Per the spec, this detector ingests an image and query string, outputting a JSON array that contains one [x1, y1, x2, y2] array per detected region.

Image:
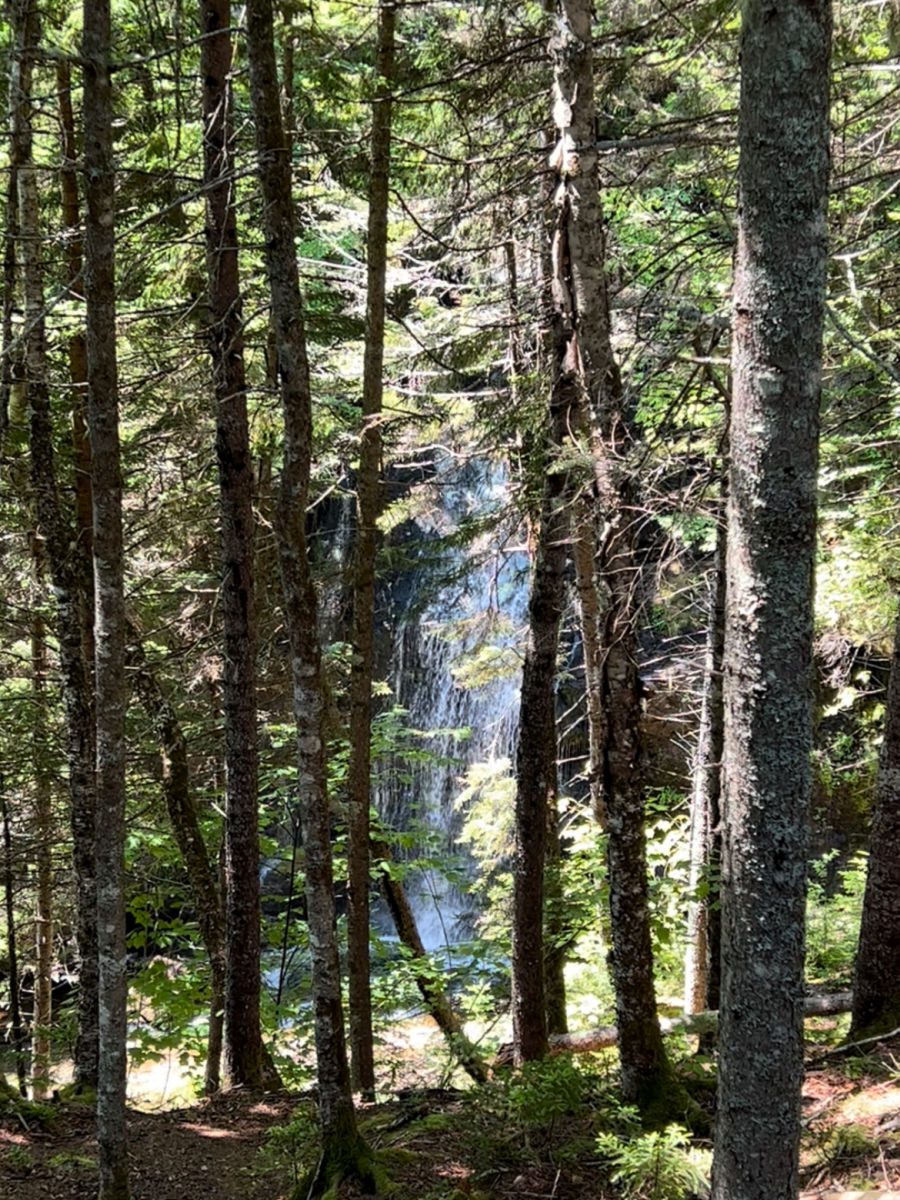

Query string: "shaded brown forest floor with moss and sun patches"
[[0, 1022, 900, 1200]]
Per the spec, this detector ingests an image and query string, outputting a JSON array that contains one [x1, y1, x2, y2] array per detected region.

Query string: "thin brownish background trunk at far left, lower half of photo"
[[31, 566, 53, 1100]]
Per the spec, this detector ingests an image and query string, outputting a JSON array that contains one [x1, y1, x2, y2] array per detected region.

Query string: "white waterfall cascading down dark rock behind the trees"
[[376, 456, 528, 949]]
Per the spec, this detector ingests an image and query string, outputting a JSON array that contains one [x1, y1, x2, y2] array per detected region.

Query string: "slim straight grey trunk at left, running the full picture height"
[[79, 0, 128, 1200]]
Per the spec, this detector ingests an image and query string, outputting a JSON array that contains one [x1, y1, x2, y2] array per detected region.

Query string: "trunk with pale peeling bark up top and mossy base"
[[551, 0, 671, 1117]]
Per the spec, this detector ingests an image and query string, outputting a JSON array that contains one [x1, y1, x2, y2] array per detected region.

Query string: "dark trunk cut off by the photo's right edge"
[[850, 609, 900, 1038]]
